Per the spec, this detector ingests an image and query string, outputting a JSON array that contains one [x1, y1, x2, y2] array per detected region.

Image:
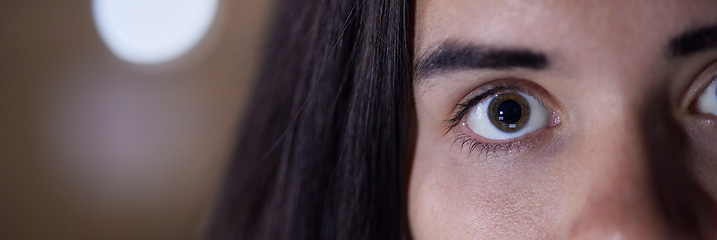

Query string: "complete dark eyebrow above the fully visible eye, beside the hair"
[[414, 42, 548, 80]]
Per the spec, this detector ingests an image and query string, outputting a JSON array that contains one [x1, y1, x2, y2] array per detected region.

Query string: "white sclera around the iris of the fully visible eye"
[[466, 93, 548, 140]]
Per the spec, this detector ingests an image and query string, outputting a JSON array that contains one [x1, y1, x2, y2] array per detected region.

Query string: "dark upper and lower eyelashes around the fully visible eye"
[[445, 83, 542, 157]]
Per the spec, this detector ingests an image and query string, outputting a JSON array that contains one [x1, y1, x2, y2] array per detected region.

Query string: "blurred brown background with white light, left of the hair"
[[0, 0, 273, 239]]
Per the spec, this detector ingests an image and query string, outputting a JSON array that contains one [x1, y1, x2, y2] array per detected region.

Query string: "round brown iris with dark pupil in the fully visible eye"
[[488, 93, 530, 132]]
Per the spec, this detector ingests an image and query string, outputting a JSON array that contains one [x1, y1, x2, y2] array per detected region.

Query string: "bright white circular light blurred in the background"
[[92, 0, 218, 64]]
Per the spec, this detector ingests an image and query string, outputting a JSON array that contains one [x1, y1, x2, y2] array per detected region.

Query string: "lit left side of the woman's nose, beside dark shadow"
[[570, 99, 666, 239]]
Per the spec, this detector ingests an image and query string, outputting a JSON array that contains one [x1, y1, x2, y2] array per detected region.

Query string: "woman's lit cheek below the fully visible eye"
[[408, 130, 567, 240]]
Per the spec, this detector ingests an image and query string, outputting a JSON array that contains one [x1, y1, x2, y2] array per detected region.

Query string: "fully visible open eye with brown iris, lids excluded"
[[464, 92, 549, 140]]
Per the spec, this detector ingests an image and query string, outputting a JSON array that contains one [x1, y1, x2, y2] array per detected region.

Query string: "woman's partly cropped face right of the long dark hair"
[[409, 0, 717, 239]]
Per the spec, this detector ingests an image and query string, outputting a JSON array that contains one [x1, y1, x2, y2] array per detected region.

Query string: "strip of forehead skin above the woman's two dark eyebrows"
[[416, 0, 717, 56]]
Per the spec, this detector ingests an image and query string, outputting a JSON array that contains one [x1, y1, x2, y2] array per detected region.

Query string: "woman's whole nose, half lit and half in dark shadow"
[[571, 90, 714, 239]]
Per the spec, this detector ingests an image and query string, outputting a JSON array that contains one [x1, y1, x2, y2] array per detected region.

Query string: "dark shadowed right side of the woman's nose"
[[640, 96, 715, 239]]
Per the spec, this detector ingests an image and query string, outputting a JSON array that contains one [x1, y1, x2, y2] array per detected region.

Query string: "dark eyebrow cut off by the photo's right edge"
[[669, 25, 717, 58]]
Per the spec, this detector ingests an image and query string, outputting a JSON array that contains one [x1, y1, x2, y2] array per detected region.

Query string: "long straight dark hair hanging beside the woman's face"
[[208, 0, 414, 239]]
